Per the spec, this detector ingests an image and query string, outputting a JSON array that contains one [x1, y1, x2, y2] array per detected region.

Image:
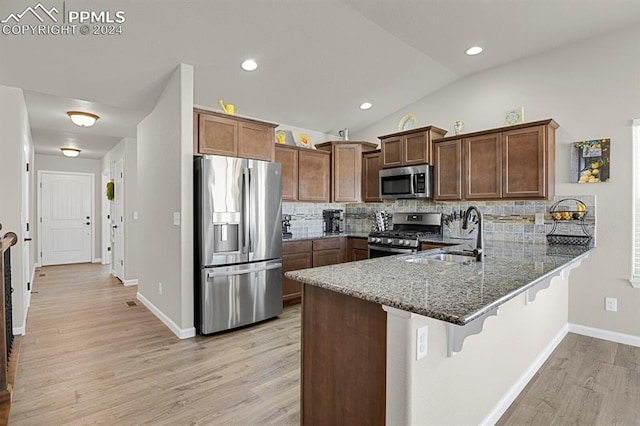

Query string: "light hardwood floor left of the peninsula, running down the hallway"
[[9, 264, 300, 425]]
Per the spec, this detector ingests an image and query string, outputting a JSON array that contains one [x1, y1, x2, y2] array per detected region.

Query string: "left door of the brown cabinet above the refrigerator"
[[198, 114, 238, 157]]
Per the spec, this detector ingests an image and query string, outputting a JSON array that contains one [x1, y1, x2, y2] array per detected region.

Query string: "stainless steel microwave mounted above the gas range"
[[379, 164, 433, 199]]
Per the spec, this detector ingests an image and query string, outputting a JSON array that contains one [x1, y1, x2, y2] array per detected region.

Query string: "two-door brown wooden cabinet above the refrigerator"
[[194, 109, 276, 161]]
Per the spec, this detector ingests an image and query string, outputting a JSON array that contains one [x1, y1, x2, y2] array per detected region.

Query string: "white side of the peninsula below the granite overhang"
[[387, 275, 568, 426]]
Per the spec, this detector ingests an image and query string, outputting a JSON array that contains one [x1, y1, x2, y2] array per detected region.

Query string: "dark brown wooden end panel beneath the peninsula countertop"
[[300, 284, 387, 426]]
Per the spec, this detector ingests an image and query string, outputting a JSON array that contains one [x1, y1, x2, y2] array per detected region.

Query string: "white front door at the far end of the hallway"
[[40, 172, 93, 265]]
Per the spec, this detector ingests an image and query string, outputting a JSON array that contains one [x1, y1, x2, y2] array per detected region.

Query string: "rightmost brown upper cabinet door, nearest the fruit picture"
[[502, 126, 547, 198]]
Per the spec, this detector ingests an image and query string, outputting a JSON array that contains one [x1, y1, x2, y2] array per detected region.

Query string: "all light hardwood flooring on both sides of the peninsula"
[[9, 264, 640, 426]]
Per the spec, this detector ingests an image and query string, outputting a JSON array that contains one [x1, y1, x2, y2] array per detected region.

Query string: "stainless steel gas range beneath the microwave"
[[368, 212, 442, 259]]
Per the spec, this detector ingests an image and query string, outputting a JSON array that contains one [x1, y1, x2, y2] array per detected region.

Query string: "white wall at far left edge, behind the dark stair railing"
[[0, 86, 35, 334]]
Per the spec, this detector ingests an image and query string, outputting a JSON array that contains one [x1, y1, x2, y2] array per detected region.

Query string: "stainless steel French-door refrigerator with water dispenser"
[[194, 155, 282, 334]]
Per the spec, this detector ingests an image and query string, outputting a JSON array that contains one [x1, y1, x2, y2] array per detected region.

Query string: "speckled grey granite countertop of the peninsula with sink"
[[285, 242, 591, 325]]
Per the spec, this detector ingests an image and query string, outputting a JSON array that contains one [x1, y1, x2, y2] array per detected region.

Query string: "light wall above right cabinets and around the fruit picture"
[[352, 27, 640, 336]]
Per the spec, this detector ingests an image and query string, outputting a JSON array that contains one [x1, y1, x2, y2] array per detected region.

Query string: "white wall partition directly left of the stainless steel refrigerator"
[[137, 64, 195, 337]]
